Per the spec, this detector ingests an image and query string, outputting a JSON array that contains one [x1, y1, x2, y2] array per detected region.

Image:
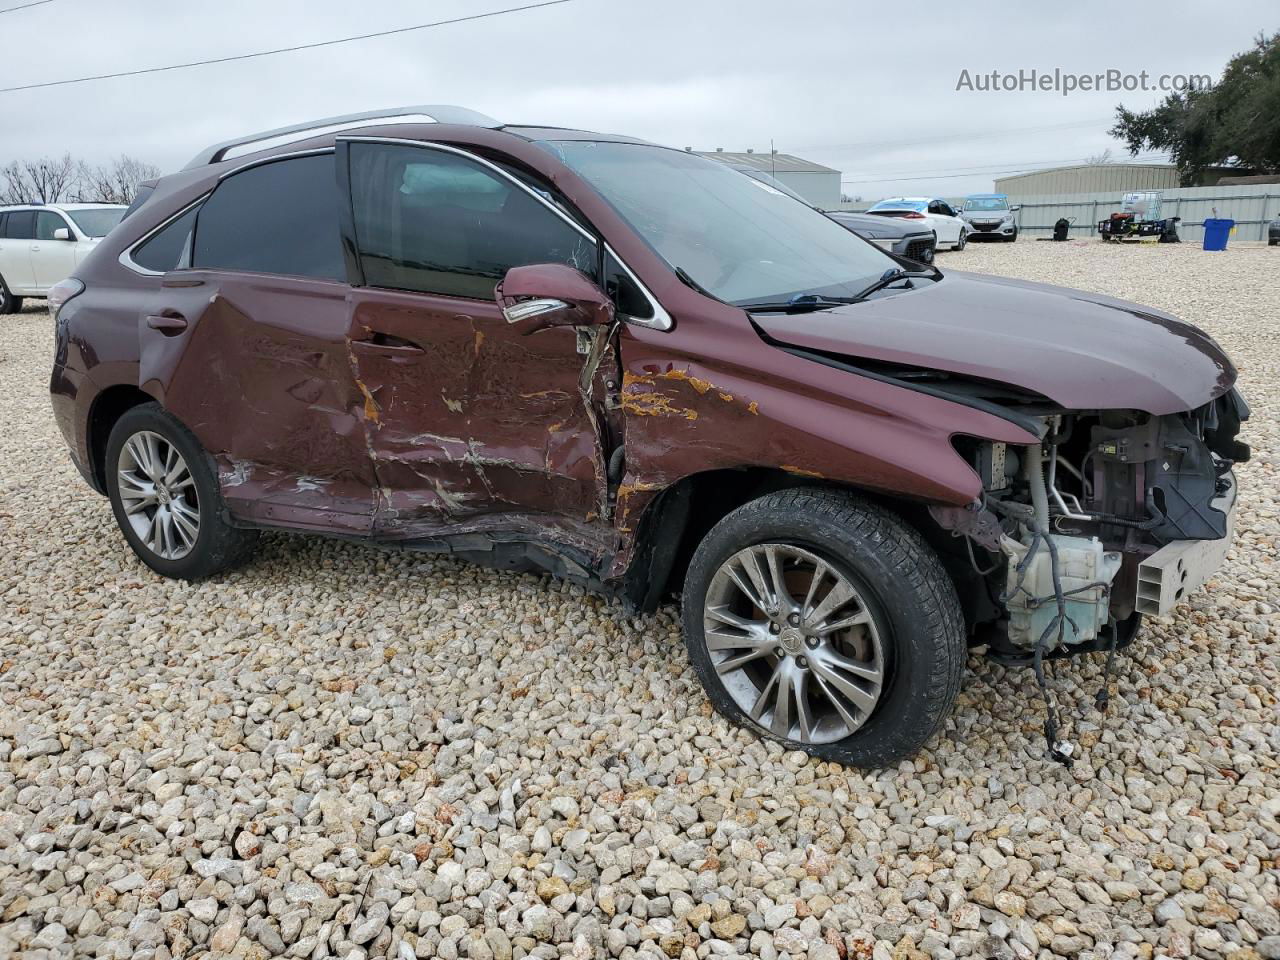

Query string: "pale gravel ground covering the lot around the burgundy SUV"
[[0, 239, 1280, 960]]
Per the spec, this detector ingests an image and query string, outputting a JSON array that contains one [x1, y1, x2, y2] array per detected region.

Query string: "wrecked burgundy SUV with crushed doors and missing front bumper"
[[51, 106, 1248, 765]]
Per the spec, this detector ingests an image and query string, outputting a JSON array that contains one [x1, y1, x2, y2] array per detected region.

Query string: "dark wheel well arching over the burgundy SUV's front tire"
[[623, 467, 964, 611]]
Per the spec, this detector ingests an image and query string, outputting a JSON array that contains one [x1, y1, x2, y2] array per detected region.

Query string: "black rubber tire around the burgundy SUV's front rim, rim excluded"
[[682, 489, 968, 768]]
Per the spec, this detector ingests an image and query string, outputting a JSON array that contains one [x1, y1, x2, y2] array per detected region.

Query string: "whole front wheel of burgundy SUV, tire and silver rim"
[[684, 489, 966, 767]]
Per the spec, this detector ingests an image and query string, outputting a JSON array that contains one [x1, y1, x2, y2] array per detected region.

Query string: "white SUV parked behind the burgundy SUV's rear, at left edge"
[[0, 204, 127, 314]]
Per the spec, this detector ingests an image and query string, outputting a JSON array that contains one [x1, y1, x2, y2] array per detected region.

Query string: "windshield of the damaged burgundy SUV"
[[543, 141, 897, 305]]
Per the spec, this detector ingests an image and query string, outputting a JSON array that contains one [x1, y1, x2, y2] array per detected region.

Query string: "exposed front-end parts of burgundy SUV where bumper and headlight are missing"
[[933, 389, 1249, 662]]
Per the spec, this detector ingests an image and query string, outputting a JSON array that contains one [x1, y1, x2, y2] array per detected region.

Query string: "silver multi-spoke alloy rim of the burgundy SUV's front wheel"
[[703, 543, 884, 744]]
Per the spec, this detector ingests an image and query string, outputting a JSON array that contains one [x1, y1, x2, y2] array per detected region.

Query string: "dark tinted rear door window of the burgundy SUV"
[[191, 154, 347, 280]]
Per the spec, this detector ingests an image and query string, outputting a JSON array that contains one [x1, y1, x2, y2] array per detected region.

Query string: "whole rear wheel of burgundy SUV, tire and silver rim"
[[106, 403, 257, 580]]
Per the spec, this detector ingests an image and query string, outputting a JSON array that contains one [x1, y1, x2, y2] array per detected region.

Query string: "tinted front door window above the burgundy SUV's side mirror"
[[351, 143, 599, 300]]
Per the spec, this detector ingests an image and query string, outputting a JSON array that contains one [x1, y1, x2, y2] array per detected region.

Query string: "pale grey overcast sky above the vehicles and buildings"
[[0, 0, 1280, 200]]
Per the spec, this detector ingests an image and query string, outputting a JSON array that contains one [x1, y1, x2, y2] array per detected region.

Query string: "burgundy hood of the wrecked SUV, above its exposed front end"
[[754, 271, 1235, 416]]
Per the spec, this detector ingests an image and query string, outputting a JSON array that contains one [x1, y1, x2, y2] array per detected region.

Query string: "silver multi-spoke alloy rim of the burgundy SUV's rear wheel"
[[116, 430, 200, 561]]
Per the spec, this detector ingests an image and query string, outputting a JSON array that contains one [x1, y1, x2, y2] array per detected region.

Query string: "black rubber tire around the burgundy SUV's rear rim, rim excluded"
[[104, 403, 259, 580]]
